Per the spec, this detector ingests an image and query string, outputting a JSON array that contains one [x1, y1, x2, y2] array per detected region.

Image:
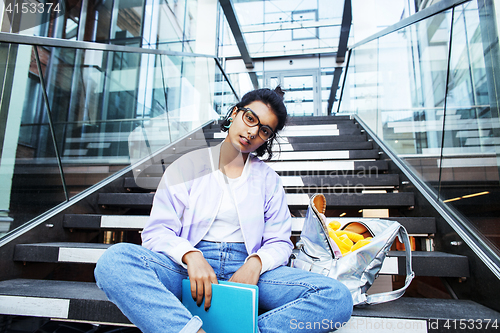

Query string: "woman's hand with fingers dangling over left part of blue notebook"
[[182, 251, 219, 311]]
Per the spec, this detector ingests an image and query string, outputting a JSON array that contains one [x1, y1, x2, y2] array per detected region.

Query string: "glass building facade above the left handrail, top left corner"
[[0, 0, 218, 56]]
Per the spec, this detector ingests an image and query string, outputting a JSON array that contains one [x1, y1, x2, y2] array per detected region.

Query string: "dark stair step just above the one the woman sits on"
[[10, 243, 469, 277]]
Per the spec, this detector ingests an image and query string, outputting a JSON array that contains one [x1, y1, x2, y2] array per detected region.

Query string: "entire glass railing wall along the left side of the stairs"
[[0, 37, 237, 235]]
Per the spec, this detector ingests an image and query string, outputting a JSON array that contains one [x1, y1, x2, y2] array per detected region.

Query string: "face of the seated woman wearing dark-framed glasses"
[[225, 101, 278, 153]]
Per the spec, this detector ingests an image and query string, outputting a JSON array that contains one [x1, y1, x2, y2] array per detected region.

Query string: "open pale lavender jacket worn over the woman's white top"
[[142, 145, 293, 269]]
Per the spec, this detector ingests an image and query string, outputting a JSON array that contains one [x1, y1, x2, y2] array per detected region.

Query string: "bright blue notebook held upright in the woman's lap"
[[182, 279, 259, 333]]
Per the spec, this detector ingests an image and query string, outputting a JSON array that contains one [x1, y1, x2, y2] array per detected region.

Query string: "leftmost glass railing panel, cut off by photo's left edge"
[[0, 43, 66, 236]]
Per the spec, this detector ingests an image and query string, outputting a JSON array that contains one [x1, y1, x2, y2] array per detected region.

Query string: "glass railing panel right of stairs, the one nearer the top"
[[341, 11, 451, 195]]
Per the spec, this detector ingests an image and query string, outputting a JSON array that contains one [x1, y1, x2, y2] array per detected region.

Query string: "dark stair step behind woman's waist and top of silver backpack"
[[63, 214, 436, 235]]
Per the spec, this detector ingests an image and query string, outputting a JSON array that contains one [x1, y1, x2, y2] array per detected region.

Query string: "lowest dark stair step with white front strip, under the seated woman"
[[0, 279, 500, 332]]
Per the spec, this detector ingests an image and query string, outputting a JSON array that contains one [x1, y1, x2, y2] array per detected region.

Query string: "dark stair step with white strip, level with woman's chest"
[[123, 174, 399, 190]]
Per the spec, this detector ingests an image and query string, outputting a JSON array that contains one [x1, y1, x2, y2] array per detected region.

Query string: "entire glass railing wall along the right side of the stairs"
[[341, 1, 500, 253]]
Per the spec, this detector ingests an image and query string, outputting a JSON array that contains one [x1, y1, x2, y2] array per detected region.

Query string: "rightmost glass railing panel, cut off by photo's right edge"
[[439, 1, 500, 252]]
